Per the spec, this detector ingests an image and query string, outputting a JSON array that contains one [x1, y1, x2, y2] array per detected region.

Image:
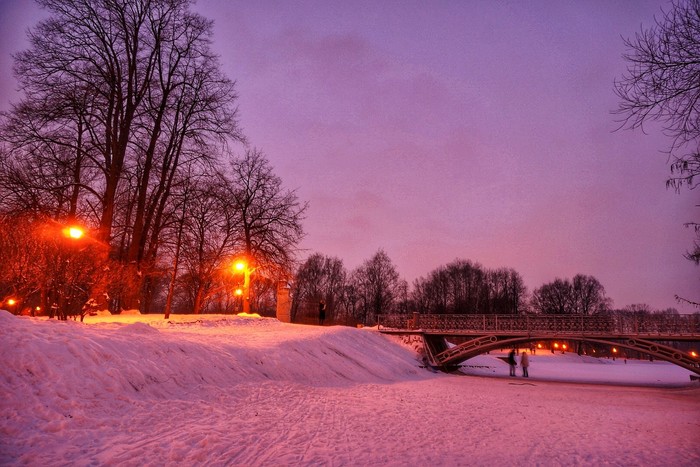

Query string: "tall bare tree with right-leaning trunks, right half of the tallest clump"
[[128, 12, 242, 270]]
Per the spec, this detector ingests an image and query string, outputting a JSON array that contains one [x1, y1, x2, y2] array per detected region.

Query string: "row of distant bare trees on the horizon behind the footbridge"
[[291, 250, 696, 325]]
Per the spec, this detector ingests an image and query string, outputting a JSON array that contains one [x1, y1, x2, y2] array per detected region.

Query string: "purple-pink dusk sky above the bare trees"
[[0, 0, 700, 311]]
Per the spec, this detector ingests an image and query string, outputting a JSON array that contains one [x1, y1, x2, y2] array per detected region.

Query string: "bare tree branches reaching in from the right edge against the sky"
[[615, 0, 700, 272]]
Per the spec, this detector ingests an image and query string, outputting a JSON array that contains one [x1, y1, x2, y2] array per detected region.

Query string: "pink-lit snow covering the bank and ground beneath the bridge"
[[0, 311, 700, 466]]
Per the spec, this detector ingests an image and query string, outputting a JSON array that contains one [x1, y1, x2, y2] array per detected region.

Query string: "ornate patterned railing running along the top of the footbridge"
[[378, 313, 700, 336]]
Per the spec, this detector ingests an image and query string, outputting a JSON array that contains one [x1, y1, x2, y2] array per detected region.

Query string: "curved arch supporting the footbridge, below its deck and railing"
[[423, 334, 700, 375]]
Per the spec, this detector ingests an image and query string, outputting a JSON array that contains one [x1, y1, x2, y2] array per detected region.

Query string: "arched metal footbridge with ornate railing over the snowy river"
[[378, 313, 700, 375]]
